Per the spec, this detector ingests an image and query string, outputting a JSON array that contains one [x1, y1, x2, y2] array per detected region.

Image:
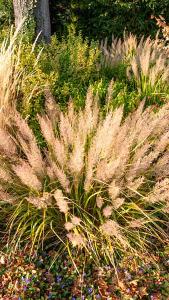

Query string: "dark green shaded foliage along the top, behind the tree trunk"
[[0, 0, 169, 40]]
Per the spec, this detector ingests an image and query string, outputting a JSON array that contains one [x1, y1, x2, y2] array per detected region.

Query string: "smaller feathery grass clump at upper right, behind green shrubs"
[[101, 34, 169, 102]]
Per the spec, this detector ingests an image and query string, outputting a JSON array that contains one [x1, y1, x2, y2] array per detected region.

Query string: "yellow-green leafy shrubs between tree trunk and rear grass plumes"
[[16, 34, 100, 114]]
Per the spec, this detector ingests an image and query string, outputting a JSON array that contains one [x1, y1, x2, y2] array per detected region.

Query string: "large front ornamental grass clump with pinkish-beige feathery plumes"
[[0, 90, 169, 262]]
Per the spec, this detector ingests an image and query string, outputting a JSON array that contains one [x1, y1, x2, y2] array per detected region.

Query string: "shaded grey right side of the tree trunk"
[[35, 0, 51, 43]]
